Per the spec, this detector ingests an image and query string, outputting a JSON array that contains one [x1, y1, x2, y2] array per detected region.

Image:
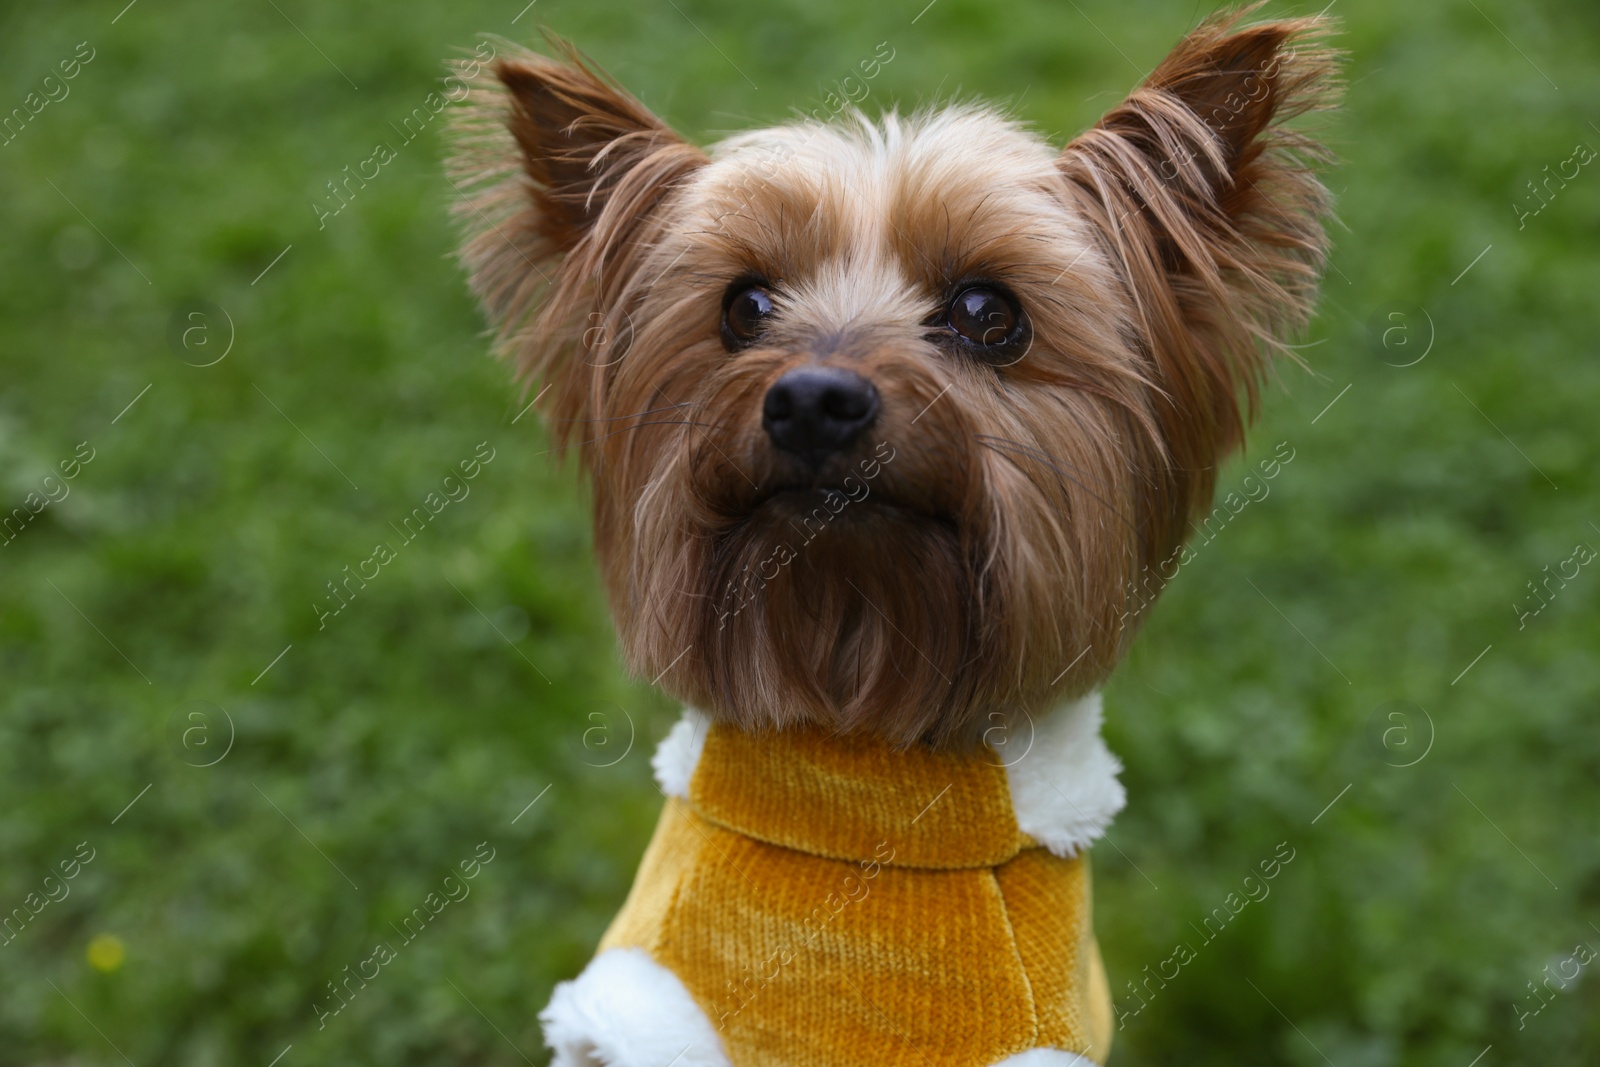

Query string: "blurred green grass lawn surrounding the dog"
[[0, 0, 1600, 1067]]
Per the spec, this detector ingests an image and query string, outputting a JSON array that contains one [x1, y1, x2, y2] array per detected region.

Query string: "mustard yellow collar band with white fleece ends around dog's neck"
[[651, 694, 1125, 869]]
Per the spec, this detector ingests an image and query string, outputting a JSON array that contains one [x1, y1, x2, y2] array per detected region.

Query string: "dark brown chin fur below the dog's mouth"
[[701, 486, 978, 744]]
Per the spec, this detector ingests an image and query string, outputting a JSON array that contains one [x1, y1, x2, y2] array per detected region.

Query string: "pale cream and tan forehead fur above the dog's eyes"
[[664, 106, 1104, 326]]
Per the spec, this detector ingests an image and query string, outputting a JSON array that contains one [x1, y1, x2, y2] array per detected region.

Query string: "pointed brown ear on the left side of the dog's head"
[[450, 37, 706, 442]]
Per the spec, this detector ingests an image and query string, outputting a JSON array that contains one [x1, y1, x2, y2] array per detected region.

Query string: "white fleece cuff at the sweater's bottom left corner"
[[539, 949, 732, 1067]]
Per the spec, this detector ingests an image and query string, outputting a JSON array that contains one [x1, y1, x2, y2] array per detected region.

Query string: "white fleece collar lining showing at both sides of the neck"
[[650, 691, 1128, 857]]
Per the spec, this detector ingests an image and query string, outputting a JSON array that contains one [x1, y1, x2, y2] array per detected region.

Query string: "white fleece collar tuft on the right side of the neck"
[[1006, 691, 1128, 857]]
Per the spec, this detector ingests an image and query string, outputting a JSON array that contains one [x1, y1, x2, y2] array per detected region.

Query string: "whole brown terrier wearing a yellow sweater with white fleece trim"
[[451, 5, 1338, 1067]]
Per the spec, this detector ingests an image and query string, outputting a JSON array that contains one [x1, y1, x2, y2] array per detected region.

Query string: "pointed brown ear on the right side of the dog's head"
[[1059, 3, 1338, 547]]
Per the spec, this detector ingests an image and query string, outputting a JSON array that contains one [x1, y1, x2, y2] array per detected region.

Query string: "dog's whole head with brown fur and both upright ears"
[[458, 8, 1331, 742]]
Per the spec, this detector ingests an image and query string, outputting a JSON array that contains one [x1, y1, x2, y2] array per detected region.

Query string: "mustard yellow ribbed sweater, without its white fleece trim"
[[600, 713, 1112, 1067]]
